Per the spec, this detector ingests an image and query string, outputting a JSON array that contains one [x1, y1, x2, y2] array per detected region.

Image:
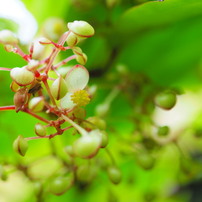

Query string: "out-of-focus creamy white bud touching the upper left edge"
[[0, 29, 18, 45]]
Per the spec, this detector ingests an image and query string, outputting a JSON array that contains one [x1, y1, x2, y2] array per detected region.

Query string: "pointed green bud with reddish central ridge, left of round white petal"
[[50, 76, 67, 100]]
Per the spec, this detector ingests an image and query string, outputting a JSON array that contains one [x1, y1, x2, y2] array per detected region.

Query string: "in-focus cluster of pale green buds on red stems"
[[0, 21, 121, 191]]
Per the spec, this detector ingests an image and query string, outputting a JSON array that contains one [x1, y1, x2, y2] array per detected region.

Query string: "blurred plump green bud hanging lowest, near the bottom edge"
[[49, 176, 73, 196]]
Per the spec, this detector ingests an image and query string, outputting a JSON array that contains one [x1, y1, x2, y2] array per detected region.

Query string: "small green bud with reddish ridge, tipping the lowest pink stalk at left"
[[13, 135, 28, 156]]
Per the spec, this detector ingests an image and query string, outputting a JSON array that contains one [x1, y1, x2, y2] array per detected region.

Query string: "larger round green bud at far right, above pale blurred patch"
[[154, 92, 177, 110]]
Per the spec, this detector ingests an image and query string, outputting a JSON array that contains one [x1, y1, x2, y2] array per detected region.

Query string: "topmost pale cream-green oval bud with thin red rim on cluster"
[[67, 20, 95, 38]]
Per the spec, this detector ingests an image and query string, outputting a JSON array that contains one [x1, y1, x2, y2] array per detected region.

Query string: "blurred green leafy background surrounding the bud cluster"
[[0, 0, 202, 202]]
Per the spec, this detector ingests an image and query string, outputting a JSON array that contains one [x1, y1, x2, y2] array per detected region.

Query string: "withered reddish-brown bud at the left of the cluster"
[[13, 88, 28, 112]]
